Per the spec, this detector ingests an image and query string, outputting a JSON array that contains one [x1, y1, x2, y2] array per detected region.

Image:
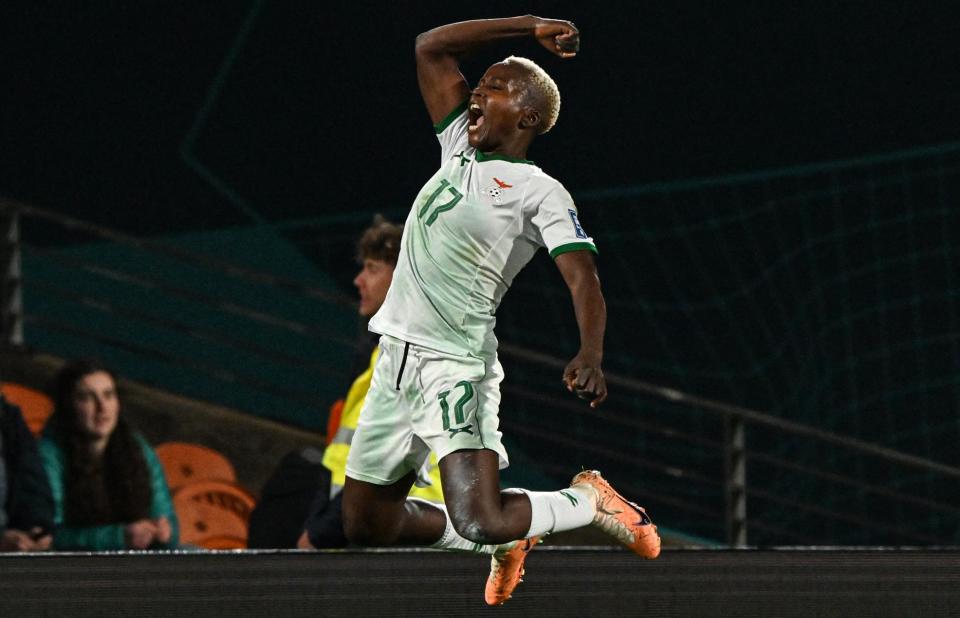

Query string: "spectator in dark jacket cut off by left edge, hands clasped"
[[0, 395, 53, 552]]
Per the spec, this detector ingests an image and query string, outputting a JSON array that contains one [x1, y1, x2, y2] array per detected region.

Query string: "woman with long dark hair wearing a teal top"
[[40, 361, 178, 551]]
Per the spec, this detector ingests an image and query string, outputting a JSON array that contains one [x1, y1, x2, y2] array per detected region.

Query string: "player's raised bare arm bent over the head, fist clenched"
[[416, 15, 580, 124]]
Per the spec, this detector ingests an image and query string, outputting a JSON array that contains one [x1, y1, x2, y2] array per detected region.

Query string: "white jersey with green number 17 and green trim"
[[370, 103, 596, 357]]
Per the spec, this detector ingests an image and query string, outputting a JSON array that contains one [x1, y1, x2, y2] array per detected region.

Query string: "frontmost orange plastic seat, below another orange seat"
[[173, 481, 256, 549]]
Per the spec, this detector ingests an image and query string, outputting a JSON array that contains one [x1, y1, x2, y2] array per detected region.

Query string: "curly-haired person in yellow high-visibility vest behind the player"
[[297, 215, 443, 549]]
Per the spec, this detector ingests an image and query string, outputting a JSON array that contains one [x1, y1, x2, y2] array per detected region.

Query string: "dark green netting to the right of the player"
[[497, 144, 960, 545]]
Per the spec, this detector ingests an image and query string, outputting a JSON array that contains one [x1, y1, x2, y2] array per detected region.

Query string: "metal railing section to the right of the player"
[[500, 344, 960, 547]]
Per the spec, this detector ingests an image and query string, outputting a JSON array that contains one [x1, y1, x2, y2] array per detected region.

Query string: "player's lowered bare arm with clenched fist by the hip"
[[556, 251, 607, 408]]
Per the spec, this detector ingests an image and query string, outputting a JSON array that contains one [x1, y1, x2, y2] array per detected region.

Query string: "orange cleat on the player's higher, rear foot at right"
[[570, 470, 660, 559]]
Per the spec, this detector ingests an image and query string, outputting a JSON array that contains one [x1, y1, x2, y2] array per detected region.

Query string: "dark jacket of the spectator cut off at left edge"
[[0, 396, 53, 532]]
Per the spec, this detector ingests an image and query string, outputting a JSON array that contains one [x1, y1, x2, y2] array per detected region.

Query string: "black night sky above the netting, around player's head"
[[0, 0, 960, 235]]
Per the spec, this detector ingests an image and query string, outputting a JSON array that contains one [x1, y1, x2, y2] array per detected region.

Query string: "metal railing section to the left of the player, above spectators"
[[0, 199, 357, 428]]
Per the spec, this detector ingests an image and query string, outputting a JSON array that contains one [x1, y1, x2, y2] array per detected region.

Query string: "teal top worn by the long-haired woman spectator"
[[39, 434, 180, 551]]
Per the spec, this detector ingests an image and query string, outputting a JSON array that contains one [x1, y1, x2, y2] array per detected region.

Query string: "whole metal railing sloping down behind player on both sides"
[[0, 194, 960, 547]]
